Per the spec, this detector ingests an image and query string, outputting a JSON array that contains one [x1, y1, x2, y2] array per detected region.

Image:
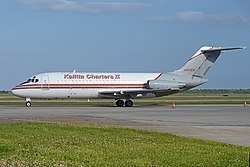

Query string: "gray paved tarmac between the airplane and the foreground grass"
[[0, 105, 250, 146]]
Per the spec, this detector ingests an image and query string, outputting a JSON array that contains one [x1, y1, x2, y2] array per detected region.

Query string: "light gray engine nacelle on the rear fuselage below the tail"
[[147, 80, 186, 89]]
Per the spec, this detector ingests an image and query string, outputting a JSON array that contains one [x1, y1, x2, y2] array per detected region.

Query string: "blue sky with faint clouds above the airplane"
[[0, 0, 250, 90]]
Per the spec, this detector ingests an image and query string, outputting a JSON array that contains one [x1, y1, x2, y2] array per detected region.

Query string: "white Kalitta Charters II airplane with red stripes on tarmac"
[[12, 46, 244, 107]]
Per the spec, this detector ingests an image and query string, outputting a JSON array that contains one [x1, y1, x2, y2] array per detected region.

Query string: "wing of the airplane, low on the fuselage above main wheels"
[[99, 88, 181, 99]]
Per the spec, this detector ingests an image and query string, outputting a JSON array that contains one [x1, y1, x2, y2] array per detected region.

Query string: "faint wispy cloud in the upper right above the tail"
[[150, 11, 250, 24]]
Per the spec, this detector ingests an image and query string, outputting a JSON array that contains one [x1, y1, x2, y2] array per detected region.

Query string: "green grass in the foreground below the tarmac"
[[0, 123, 249, 167]]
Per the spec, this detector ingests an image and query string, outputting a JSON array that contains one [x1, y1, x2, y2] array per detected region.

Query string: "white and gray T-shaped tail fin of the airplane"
[[175, 46, 244, 78]]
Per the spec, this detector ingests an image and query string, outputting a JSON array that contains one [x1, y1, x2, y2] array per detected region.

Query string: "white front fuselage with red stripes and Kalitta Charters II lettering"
[[12, 72, 162, 99]]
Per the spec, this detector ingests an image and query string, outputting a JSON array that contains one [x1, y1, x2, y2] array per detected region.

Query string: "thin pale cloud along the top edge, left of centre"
[[19, 0, 150, 13]]
